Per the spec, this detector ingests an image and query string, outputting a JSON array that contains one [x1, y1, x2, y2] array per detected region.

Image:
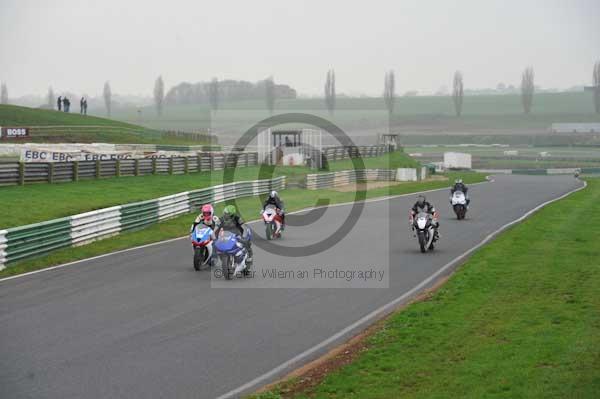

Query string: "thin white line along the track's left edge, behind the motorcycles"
[[0, 181, 488, 283]]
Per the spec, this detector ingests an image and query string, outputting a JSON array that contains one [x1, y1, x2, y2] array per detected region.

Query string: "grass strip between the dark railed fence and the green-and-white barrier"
[[0, 152, 418, 229]]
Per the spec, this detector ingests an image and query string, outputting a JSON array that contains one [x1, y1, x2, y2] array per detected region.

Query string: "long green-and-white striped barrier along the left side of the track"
[[0, 176, 285, 270]]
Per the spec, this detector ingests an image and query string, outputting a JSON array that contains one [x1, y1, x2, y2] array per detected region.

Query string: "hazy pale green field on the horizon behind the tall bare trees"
[[99, 92, 600, 134]]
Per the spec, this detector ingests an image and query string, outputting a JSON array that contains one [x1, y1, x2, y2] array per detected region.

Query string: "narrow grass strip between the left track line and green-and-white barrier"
[[0, 173, 485, 277]]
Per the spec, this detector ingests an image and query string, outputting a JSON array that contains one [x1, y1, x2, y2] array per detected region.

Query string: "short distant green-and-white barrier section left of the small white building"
[[305, 168, 427, 190]]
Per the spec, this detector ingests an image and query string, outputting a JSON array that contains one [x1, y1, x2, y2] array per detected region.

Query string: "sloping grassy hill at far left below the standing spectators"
[[0, 105, 214, 145]]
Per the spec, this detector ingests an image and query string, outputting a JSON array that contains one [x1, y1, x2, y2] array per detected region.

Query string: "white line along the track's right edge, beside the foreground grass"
[[217, 180, 587, 399]]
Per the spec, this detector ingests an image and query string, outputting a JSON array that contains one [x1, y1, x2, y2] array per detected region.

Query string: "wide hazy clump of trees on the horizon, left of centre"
[[164, 78, 297, 105]]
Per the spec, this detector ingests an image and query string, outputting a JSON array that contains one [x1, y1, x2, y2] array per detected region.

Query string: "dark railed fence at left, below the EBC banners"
[[0, 152, 258, 185]]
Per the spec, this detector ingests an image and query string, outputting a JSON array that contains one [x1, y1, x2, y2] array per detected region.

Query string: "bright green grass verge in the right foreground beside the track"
[[258, 179, 600, 398]]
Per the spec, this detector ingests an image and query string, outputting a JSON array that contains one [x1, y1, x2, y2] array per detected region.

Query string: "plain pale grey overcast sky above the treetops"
[[0, 0, 600, 97]]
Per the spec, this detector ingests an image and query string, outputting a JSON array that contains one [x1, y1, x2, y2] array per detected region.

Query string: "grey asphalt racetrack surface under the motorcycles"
[[0, 175, 582, 399]]
